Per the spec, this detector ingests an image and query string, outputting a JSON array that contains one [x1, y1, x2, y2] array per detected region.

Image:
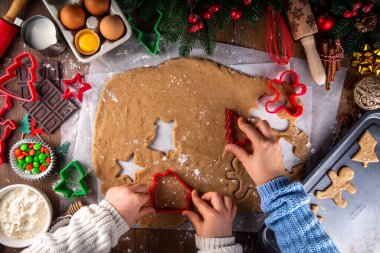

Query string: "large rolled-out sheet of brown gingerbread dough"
[[93, 58, 309, 228]]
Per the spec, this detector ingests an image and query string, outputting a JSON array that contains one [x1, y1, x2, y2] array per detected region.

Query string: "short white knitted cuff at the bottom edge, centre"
[[195, 235, 243, 253]]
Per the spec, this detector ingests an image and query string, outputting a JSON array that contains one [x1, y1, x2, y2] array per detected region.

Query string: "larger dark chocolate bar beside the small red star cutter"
[[19, 79, 78, 134]]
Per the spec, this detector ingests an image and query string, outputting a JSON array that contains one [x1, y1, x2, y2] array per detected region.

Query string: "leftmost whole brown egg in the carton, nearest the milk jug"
[[60, 4, 86, 30]]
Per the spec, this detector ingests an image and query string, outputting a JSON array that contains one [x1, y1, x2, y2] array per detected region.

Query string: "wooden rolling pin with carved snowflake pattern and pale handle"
[[286, 0, 326, 85]]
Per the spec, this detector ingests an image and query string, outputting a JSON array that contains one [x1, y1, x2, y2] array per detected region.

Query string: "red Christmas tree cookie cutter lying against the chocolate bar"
[[0, 52, 38, 102]]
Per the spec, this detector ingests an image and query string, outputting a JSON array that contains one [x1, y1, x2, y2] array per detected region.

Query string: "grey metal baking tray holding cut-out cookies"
[[261, 109, 380, 253]]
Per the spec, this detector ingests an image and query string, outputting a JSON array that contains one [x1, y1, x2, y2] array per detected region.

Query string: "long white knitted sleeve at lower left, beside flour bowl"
[[23, 200, 129, 253]]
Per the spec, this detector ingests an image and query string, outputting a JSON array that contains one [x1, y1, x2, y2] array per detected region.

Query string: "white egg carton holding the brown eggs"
[[42, 0, 132, 62]]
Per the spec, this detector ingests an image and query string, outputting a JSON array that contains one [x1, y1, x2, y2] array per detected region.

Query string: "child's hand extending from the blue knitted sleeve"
[[226, 118, 285, 186]]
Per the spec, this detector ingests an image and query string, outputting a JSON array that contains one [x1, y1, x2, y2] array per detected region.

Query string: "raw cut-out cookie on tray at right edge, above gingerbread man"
[[352, 130, 379, 168]]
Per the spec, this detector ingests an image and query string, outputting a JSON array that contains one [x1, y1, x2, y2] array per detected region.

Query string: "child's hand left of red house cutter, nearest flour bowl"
[[105, 184, 155, 226]]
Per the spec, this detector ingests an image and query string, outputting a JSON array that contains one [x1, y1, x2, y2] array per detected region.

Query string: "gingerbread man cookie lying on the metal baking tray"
[[315, 167, 356, 208]]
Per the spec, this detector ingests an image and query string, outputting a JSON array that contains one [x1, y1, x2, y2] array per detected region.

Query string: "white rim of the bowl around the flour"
[[0, 184, 53, 248]]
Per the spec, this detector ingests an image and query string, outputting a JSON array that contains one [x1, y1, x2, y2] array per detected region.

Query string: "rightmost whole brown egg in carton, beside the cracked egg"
[[100, 15, 125, 40]]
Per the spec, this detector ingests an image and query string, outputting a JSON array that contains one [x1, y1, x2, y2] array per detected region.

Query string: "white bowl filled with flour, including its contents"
[[0, 184, 53, 248]]
